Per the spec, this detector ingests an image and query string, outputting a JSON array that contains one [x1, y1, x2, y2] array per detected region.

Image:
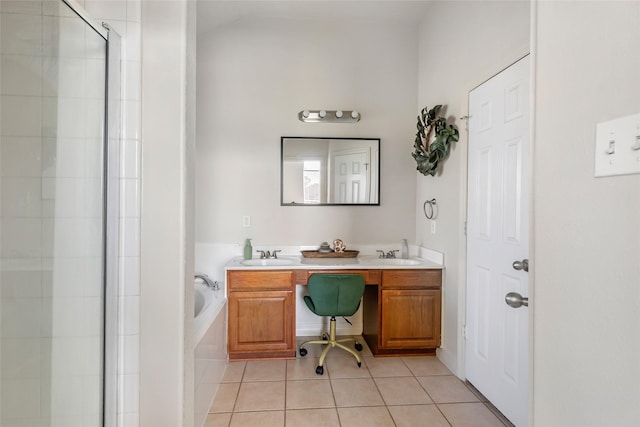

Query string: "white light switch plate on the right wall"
[[595, 114, 640, 177]]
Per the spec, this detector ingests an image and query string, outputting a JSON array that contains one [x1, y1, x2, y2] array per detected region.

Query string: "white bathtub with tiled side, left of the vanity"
[[193, 283, 228, 427]]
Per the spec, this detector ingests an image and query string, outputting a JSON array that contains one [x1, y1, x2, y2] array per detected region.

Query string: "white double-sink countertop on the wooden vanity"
[[225, 255, 444, 270]]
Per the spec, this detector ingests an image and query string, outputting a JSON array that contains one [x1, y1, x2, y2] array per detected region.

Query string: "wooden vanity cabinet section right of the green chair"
[[365, 270, 442, 355]]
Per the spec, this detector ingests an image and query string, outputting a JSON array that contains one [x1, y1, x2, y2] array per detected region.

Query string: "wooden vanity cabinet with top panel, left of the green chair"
[[227, 270, 296, 360]]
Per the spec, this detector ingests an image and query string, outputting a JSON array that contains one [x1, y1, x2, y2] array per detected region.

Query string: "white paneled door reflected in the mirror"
[[331, 151, 371, 203]]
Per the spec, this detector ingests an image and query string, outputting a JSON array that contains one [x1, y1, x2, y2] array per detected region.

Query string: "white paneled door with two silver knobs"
[[465, 56, 530, 427]]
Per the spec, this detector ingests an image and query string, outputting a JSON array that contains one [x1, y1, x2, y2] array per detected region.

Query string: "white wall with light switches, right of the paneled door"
[[533, 1, 640, 426]]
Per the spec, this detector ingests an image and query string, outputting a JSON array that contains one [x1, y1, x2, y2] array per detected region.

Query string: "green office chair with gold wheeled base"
[[300, 274, 364, 375]]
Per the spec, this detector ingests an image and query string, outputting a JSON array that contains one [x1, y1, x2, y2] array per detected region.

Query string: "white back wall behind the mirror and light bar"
[[196, 18, 418, 248]]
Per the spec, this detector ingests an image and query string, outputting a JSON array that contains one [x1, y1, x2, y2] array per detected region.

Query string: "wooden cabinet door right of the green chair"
[[380, 289, 440, 349]]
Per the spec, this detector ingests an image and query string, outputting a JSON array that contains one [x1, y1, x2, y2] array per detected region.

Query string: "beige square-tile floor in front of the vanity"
[[204, 337, 511, 427]]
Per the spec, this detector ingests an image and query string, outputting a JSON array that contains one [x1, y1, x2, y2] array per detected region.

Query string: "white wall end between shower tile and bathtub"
[[140, 0, 194, 426]]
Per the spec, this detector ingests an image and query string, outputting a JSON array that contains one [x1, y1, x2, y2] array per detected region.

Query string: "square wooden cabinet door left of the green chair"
[[229, 291, 295, 353]]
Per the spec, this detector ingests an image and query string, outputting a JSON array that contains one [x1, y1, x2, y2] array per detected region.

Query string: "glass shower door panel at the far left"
[[0, 1, 107, 427]]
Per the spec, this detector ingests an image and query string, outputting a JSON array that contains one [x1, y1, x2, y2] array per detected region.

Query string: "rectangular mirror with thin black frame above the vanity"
[[280, 136, 380, 206]]
